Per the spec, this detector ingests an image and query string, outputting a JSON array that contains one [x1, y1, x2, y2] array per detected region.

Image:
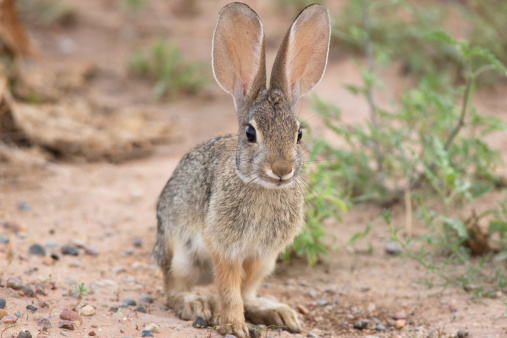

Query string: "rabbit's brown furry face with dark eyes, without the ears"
[[236, 90, 303, 188]]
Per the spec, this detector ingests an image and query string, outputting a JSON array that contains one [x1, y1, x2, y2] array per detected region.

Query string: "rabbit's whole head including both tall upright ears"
[[212, 3, 330, 188]]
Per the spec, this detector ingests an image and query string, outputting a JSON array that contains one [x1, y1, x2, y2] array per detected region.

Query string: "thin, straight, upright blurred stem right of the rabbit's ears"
[[361, 0, 384, 180]]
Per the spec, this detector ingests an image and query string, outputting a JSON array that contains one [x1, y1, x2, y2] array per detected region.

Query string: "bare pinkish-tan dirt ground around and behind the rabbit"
[[0, 0, 507, 337]]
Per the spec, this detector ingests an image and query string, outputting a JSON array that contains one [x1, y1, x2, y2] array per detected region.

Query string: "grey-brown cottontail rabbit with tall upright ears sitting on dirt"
[[152, 3, 331, 337]]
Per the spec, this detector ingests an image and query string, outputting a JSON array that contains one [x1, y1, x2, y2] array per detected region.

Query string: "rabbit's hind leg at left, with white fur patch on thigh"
[[163, 241, 215, 323]]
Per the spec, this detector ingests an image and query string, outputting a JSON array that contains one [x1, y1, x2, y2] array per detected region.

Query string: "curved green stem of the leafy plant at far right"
[[382, 75, 473, 208]]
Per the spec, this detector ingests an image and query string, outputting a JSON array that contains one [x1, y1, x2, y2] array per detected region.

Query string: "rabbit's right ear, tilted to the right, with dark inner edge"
[[271, 4, 331, 107]]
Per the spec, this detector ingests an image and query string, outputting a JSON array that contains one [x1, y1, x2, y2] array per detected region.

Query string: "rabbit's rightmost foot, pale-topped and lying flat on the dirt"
[[245, 298, 302, 332]]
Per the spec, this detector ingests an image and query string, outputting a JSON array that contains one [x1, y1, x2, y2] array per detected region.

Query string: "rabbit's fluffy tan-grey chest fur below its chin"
[[205, 186, 304, 257]]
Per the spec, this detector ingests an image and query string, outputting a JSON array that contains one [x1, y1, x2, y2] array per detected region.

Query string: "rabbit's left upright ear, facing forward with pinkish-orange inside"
[[212, 2, 266, 110]]
